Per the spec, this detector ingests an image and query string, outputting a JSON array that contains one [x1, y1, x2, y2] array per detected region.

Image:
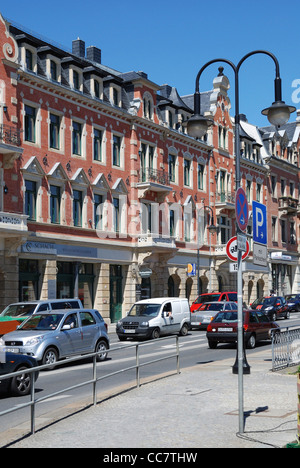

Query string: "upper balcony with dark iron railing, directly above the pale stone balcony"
[[137, 168, 172, 199]]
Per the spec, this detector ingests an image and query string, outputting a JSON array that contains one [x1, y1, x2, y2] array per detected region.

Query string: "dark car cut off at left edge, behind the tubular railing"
[[0, 353, 39, 396]]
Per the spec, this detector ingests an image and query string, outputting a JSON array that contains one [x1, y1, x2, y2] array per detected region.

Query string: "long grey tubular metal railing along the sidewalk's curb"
[[0, 335, 180, 434]]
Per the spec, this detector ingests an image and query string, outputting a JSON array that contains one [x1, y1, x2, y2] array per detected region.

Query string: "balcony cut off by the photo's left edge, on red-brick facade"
[[0, 124, 23, 169]]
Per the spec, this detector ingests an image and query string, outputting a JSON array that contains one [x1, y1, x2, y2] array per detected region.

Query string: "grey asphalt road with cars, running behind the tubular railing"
[[0, 313, 300, 440]]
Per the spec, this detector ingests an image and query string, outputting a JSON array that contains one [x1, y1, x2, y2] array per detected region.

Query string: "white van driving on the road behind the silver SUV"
[[116, 297, 191, 341]]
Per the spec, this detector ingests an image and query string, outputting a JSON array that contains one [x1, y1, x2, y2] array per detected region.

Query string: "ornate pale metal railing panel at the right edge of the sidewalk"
[[272, 327, 300, 371]]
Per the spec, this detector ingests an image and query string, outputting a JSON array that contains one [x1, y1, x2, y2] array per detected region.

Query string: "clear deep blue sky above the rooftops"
[[0, 0, 300, 127]]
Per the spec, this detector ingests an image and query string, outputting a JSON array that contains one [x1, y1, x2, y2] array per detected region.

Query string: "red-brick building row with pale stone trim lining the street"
[[0, 16, 300, 322]]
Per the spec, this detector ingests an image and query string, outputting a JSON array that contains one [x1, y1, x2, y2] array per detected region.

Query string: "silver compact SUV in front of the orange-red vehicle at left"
[[0, 309, 109, 365]]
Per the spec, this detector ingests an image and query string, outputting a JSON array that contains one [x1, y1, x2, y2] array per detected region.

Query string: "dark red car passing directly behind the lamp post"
[[206, 310, 279, 349]]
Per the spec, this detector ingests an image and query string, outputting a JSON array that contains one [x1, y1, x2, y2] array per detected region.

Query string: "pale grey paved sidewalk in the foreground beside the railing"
[[5, 351, 298, 450]]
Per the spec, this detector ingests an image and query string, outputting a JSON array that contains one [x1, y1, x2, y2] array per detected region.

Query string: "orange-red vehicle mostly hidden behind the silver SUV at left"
[[0, 299, 83, 336]]
